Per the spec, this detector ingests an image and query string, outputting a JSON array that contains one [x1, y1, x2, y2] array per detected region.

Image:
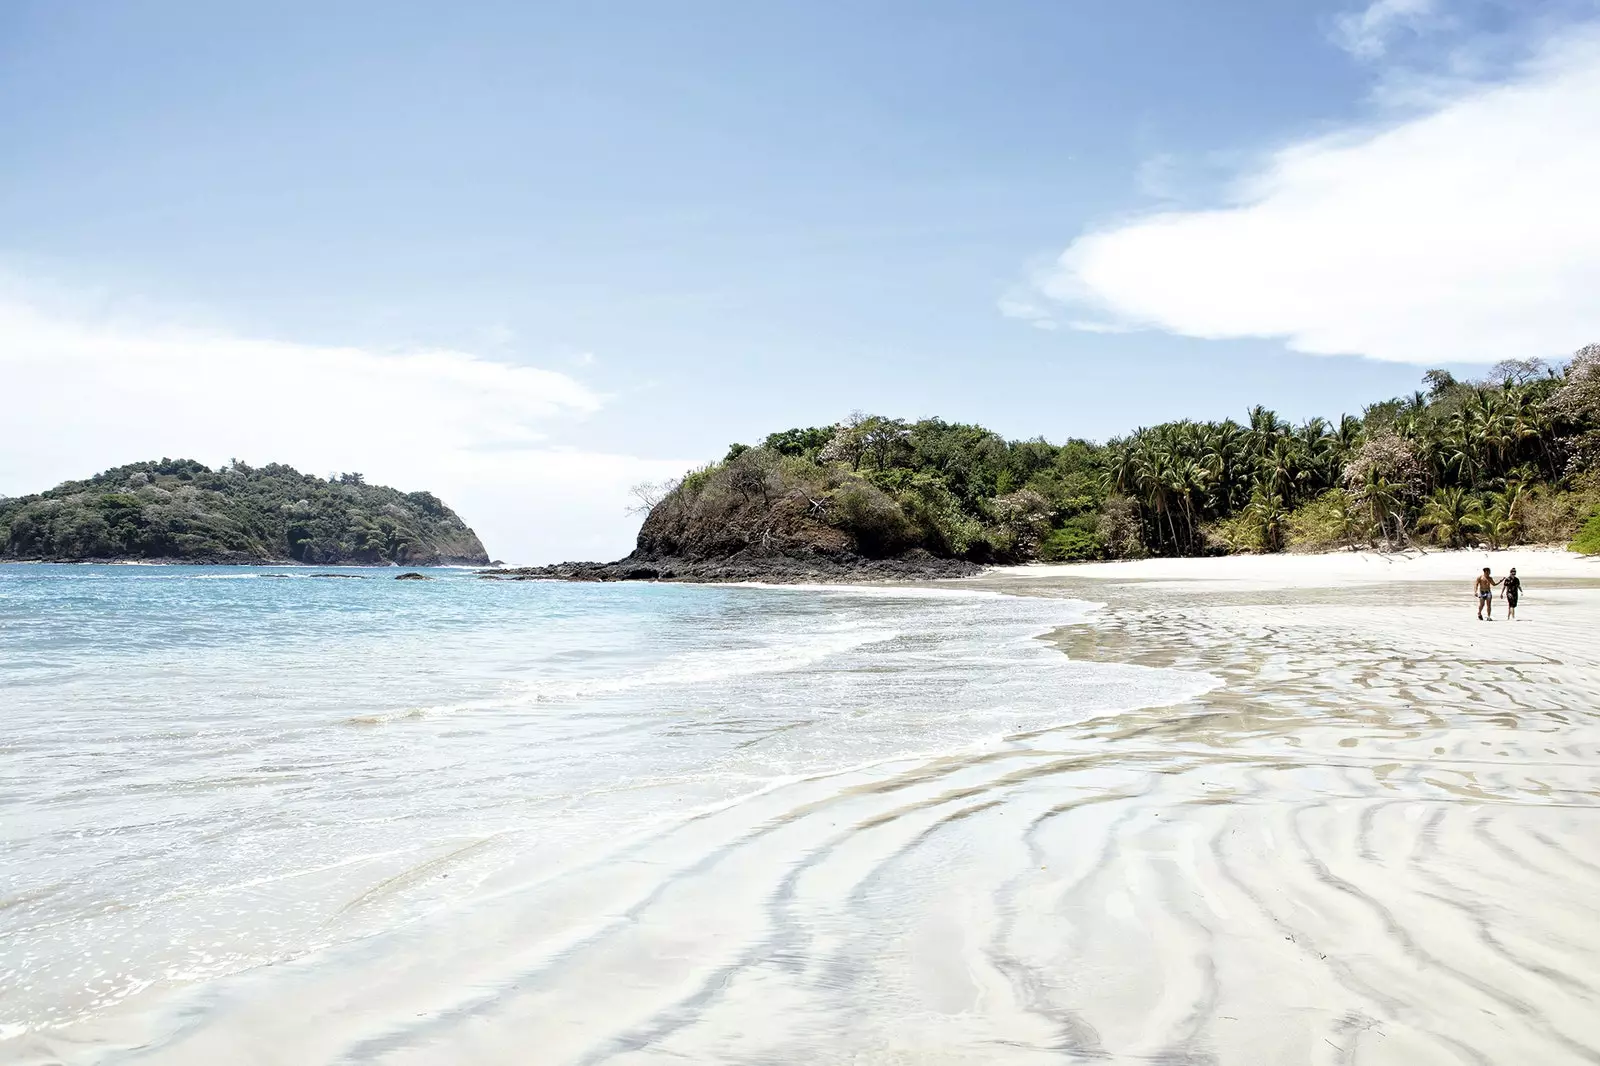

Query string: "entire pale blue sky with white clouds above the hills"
[[0, 0, 1600, 563]]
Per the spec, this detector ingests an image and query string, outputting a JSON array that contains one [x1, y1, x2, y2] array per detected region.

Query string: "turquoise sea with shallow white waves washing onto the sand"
[[0, 565, 1195, 1039]]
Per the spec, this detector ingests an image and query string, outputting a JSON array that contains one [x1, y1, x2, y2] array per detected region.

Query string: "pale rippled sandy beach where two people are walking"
[[11, 552, 1600, 1066]]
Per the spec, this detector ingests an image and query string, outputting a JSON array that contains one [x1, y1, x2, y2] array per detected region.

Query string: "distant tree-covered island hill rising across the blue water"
[[0, 459, 490, 567]]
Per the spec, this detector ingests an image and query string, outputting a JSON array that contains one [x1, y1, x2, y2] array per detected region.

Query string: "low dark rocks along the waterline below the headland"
[[478, 552, 986, 584]]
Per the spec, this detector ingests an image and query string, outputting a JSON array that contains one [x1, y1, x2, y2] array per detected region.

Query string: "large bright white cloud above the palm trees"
[[1038, 27, 1600, 363]]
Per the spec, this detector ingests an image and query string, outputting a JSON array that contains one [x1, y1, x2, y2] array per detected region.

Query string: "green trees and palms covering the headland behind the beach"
[[640, 346, 1600, 562]]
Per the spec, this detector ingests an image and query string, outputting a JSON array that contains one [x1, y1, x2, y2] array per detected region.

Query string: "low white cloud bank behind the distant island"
[[0, 286, 688, 562]]
